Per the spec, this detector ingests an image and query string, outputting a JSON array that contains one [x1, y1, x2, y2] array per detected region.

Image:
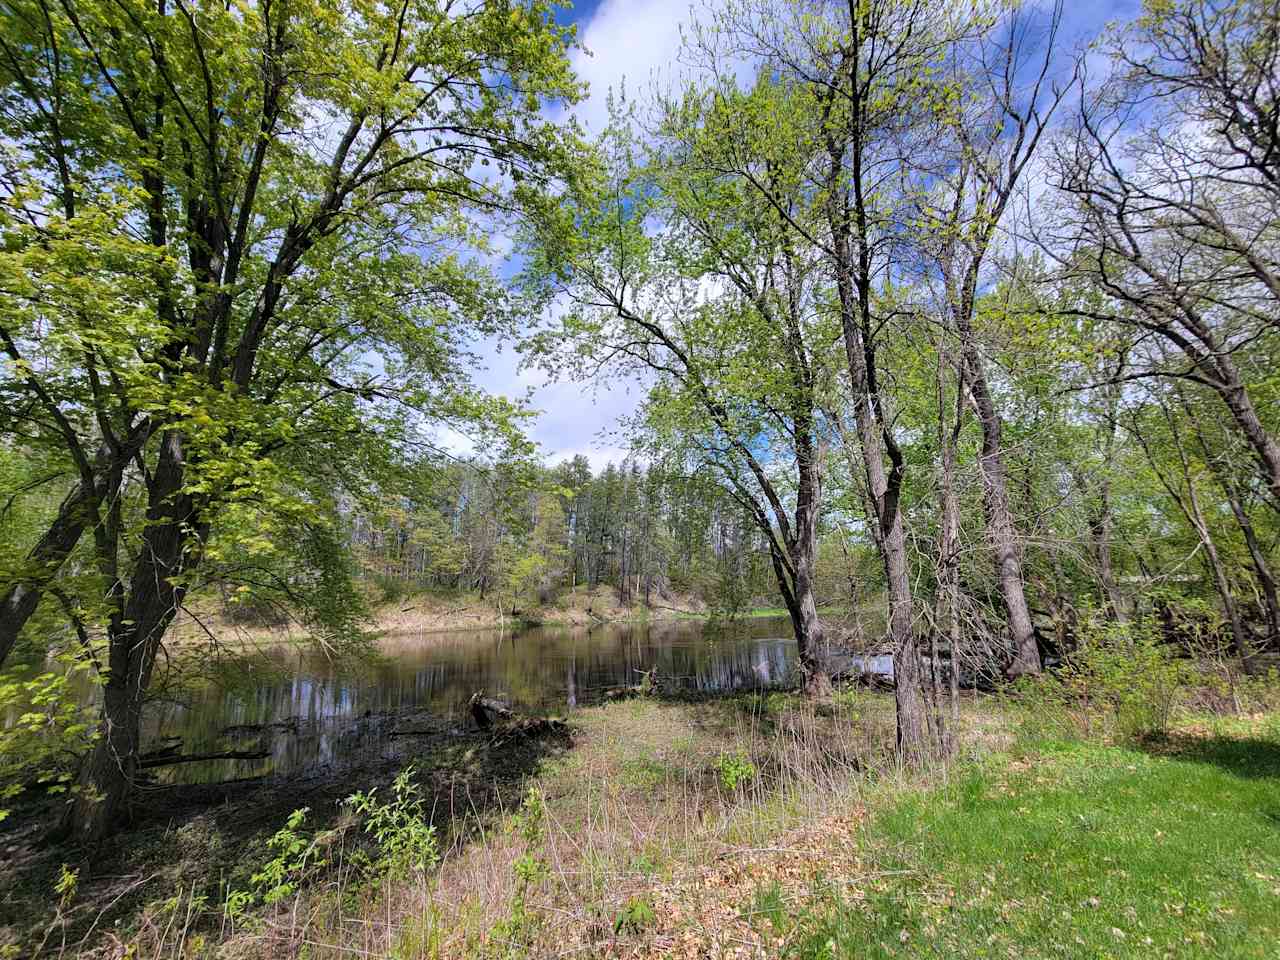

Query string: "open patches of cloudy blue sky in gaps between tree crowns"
[[476, 0, 1138, 470]]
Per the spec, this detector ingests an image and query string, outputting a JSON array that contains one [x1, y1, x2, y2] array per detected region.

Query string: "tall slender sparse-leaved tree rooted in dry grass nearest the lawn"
[[700, 0, 963, 758]]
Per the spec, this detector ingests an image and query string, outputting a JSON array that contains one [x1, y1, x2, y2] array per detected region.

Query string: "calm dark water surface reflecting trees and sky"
[[146, 618, 795, 782]]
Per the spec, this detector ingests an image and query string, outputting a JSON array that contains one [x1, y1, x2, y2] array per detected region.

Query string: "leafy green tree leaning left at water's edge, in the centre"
[[524, 86, 832, 692]]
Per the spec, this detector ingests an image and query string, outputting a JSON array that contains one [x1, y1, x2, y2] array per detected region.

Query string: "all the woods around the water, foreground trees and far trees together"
[[0, 0, 1280, 931]]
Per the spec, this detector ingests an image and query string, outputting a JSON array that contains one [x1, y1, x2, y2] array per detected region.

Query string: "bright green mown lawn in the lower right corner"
[[788, 723, 1280, 957]]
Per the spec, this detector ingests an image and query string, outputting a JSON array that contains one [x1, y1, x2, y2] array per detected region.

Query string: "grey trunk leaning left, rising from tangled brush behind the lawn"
[[964, 350, 1041, 678]]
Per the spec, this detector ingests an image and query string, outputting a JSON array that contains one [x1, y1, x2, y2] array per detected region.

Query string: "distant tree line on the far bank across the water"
[[342, 454, 773, 609]]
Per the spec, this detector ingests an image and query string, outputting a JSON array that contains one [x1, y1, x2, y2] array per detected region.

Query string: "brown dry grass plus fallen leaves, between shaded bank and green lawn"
[[165, 694, 989, 959]]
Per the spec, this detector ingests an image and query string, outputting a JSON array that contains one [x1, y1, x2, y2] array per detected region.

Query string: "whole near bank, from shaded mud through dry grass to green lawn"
[[12, 689, 1280, 960]]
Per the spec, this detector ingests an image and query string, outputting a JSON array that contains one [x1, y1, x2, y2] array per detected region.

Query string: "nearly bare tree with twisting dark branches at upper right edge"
[[1041, 0, 1280, 511]]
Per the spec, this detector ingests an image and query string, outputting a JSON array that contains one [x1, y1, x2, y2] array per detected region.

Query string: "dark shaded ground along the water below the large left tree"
[[0, 716, 572, 956]]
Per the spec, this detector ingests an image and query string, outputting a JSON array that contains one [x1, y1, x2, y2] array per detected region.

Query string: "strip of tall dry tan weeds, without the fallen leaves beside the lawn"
[[202, 694, 892, 960]]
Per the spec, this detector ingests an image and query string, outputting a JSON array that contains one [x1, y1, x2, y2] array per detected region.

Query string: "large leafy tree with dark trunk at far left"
[[0, 0, 577, 840]]
